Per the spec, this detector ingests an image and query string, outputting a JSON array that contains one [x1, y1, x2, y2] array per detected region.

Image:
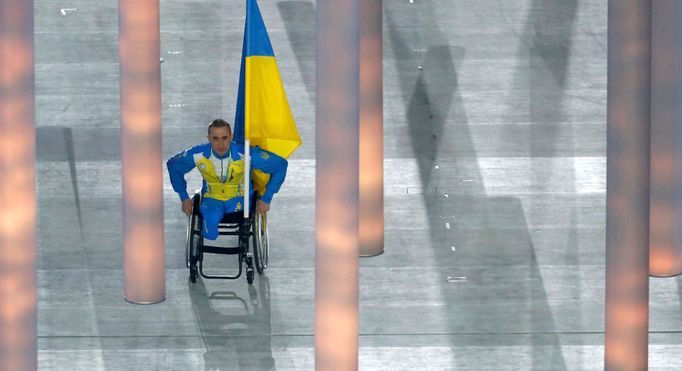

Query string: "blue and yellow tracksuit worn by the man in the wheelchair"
[[166, 141, 287, 240]]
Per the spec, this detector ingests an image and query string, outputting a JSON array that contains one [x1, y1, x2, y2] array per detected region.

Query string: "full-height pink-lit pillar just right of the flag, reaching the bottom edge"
[[315, 0, 360, 371]]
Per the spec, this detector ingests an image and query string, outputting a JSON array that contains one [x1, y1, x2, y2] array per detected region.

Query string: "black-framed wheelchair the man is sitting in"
[[185, 191, 269, 285]]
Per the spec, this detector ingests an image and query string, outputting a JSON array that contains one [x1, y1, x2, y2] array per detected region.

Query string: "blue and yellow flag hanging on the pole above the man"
[[234, 0, 301, 159]]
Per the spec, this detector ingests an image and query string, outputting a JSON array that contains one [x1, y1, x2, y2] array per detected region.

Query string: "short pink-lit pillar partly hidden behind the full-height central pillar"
[[359, 0, 384, 256]]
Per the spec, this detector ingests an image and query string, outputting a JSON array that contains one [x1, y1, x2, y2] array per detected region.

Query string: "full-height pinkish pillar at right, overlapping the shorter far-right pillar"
[[604, 0, 651, 371]]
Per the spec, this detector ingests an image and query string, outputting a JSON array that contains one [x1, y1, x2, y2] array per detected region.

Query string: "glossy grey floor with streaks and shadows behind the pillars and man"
[[35, 0, 682, 371]]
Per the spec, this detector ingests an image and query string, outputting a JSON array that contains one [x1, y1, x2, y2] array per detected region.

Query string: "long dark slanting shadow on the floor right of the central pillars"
[[384, 1, 567, 370]]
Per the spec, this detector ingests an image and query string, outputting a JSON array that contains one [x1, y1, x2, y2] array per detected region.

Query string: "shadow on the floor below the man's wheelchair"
[[188, 276, 276, 371]]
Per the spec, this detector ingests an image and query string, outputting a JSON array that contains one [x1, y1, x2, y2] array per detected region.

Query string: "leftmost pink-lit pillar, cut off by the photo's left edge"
[[0, 0, 38, 371]]
